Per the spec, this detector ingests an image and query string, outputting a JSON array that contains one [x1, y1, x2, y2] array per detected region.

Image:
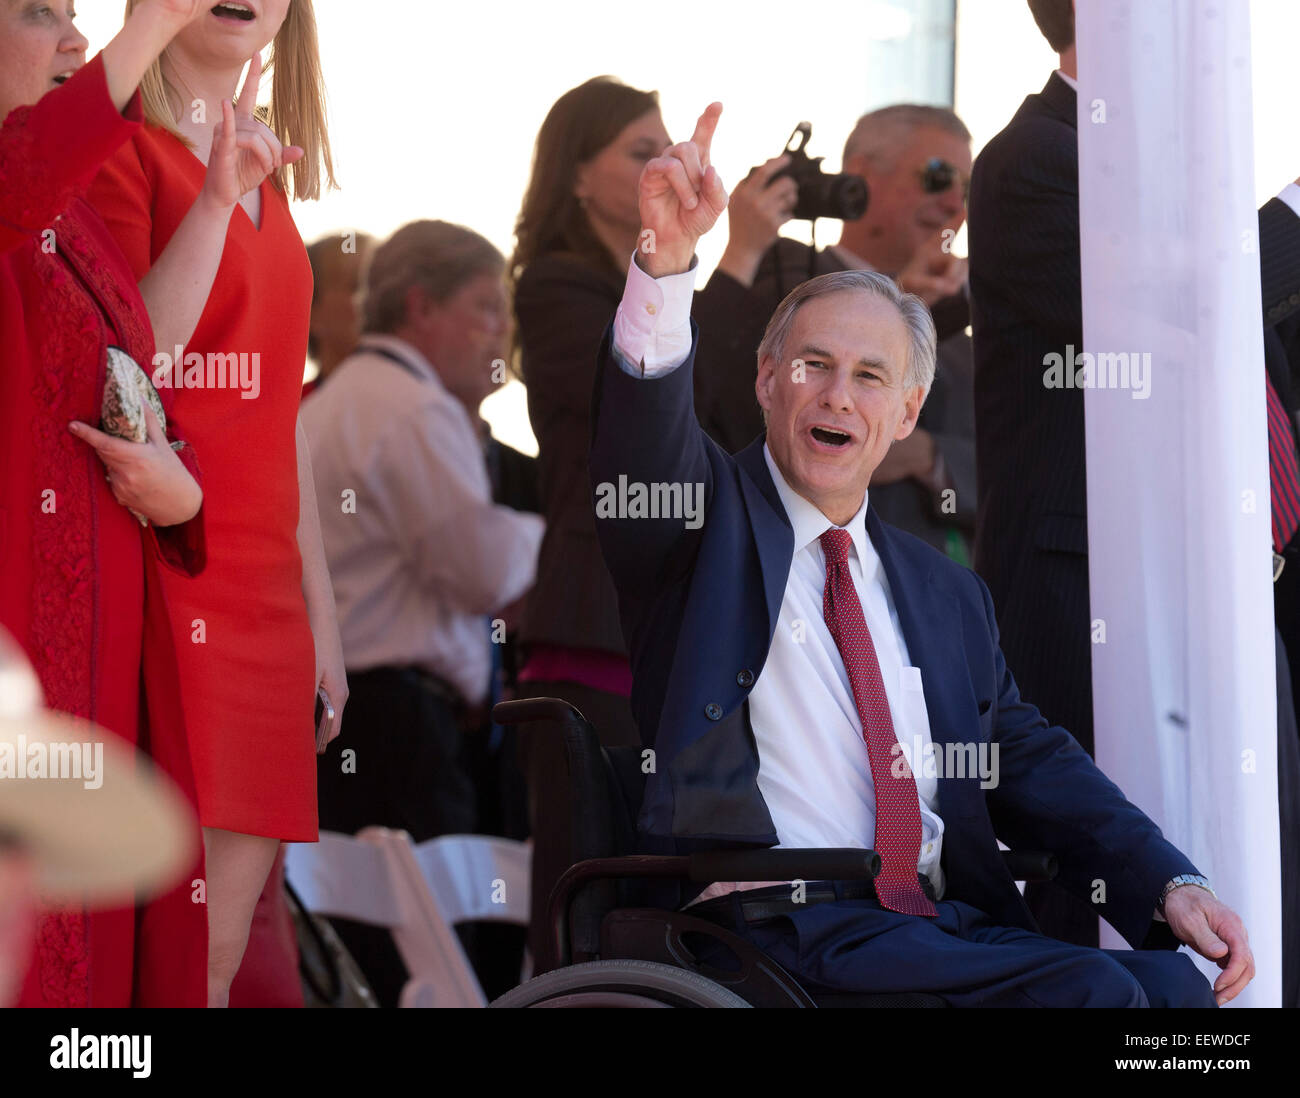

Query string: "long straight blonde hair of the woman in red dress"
[[126, 0, 338, 199]]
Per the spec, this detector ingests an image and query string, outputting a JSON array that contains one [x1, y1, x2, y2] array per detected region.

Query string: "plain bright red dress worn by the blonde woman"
[[90, 126, 317, 842]]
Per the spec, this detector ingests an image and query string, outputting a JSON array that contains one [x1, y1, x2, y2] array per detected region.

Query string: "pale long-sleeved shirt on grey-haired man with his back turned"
[[302, 335, 543, 706]]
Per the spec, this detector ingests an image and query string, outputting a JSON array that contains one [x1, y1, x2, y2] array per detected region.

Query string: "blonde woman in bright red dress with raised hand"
[[90, 0, 347, 1006]]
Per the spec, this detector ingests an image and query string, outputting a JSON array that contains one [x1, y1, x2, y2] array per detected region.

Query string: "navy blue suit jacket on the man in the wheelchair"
[[590, 322, 1196, 947]]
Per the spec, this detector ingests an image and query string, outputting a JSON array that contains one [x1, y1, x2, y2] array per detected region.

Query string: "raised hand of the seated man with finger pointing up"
[[637, 103, 727, 278]]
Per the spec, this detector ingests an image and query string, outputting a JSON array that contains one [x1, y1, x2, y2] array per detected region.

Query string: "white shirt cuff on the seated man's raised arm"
[[614, 250, 702, 378]]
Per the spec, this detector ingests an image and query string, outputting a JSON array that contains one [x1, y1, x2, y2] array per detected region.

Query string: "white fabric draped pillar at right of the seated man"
[[1076, 0, 1282, 1006]]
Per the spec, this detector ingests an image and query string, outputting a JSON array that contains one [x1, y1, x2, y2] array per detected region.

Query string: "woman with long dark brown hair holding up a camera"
[[508, 77, 797, 972]]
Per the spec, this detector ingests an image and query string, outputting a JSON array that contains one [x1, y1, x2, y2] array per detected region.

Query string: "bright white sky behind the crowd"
[[78, 0, 1300, 452]]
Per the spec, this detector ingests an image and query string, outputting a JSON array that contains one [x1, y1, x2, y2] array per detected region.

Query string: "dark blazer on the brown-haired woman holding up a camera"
[[515, 253, 754, 654]]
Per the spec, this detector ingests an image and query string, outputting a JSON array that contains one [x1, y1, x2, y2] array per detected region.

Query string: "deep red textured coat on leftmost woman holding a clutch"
[[0, 57, 207, 1006]]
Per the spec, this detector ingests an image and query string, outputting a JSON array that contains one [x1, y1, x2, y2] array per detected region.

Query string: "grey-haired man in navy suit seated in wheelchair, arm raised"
[[579, 104, 1255, 1006]]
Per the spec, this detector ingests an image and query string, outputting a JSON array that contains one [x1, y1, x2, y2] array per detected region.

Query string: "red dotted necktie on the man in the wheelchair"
[[820, 526, 939, 915]]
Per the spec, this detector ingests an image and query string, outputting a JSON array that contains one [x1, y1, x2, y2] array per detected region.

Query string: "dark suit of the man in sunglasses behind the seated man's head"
[[696, 238, 976, 555]]
